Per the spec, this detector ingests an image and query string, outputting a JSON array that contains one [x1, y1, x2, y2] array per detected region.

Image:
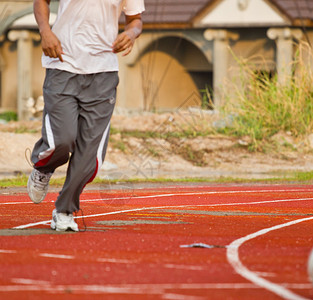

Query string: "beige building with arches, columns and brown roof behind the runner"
[[0, 0, 313, 118]]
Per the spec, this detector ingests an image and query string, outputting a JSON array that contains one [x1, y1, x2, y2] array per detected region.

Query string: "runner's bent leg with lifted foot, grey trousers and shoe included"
[[27, 70, 79, 203]]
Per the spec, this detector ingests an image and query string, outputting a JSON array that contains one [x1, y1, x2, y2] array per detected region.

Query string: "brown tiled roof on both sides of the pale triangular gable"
[[143, 0, 313, 27]]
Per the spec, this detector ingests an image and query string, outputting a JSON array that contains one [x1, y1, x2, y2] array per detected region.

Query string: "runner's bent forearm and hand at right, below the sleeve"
[[112, 14, 142, 56]]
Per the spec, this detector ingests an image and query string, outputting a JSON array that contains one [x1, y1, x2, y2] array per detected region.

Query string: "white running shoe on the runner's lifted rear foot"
[[27, 169, 52, 204]]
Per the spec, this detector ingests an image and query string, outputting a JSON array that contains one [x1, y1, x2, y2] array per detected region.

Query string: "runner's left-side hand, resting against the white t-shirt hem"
[[41, 29, 64, 62]]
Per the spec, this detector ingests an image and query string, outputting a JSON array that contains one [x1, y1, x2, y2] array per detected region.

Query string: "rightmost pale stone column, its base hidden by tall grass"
[[267, 28, 302, 84]]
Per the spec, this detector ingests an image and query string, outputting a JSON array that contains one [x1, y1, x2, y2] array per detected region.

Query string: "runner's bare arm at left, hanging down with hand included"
[[34, 0, 63, 62]]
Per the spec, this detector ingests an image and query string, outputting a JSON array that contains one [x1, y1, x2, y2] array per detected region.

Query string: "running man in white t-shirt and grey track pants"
[[27, 0, 144, 231]]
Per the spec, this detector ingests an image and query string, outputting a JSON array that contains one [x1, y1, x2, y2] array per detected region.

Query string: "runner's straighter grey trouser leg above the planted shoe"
[[56, 72, 118, 214]]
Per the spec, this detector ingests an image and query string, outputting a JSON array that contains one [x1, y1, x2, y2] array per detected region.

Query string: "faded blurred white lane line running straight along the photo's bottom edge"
[[0, 283, 312, 295]]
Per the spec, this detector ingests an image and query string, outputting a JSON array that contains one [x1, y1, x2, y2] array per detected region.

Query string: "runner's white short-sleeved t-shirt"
[[42, 0, 144, 74]]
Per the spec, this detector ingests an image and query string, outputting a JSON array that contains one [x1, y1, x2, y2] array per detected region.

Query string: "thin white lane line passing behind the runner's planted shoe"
[[13, 198, 313, 229]]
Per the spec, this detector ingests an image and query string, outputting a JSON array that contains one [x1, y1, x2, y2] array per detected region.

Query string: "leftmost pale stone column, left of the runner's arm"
[[8, 30, 40, 120]]
